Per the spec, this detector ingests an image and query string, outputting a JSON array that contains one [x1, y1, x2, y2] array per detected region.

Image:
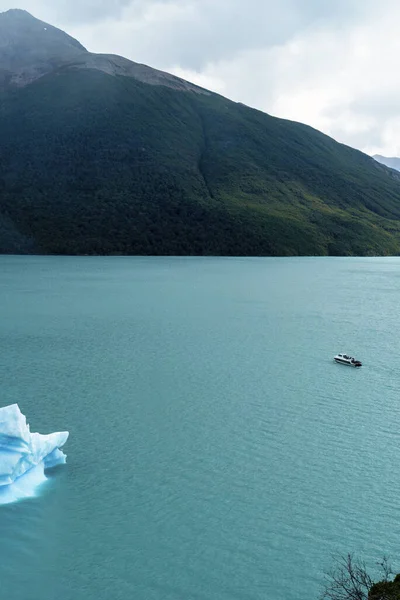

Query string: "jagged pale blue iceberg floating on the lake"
[[0, 404, 69, 504]]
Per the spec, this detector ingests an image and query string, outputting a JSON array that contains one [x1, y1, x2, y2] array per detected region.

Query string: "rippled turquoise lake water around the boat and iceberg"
[[0, 257, 400, 600]]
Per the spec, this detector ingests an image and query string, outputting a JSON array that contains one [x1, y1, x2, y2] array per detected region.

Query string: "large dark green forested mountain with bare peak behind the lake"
[[0, 11, 400, 255]]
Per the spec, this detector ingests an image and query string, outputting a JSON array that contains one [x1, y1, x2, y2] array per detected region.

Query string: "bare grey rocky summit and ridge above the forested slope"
[[0, 9, 209, 94]]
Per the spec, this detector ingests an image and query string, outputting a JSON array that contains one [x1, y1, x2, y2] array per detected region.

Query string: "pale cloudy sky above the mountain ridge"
[[0, 0, 400, 156]]
